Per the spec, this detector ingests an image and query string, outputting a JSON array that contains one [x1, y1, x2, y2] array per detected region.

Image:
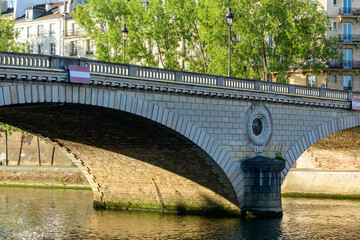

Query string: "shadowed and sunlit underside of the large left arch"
[[0, 103, 239, 214]]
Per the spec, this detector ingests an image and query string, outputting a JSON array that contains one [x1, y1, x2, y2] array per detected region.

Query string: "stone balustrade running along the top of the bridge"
[[0, 52, 360, 108]]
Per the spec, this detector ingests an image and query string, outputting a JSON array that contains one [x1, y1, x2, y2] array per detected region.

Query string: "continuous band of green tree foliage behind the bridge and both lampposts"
[[72, 0, 339, 82]]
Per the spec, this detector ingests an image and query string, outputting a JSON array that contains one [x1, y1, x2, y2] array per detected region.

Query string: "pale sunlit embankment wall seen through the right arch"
[[281, 168, 360, 197]]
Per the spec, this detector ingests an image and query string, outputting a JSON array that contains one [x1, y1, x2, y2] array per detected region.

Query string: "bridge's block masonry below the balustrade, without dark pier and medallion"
[[0, 76, 360, 215]]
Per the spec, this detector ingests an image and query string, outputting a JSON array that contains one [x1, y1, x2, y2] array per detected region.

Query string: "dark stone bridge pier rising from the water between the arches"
[[241, 156, 285, 217]]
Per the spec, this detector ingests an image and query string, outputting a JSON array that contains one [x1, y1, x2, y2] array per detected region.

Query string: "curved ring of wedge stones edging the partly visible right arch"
[[281, 115, 360, 180]]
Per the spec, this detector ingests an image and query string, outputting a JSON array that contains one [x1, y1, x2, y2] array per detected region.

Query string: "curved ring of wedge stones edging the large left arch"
[[0, 82, 244, 212]]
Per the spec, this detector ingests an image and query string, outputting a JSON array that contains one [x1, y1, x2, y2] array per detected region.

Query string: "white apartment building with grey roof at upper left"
[[0, 0, 94, 58]]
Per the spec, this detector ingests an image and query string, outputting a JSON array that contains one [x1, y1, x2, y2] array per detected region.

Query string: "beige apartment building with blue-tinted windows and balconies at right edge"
[[290, 0, 360, 91]]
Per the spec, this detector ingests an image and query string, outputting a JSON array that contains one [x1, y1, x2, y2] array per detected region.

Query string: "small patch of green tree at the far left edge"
[[0, 15, 26, 52]]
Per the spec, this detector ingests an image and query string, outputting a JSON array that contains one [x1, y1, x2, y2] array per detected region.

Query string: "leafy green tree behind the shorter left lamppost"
[[72, 0, 186, 69]]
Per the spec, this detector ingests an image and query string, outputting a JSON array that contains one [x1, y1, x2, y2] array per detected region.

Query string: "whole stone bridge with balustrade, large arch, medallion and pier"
[[0, 52, 360, 217]]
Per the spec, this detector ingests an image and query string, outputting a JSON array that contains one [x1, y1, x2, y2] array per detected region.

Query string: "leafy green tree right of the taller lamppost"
[[234, 0, 339, 82]]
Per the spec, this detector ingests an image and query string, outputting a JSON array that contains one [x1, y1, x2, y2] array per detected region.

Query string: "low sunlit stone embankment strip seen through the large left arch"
[[0, 166, 89, 187]]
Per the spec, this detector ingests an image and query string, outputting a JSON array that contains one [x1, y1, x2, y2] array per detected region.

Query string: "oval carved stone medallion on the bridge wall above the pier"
[[244, 103, 272, 153]]
